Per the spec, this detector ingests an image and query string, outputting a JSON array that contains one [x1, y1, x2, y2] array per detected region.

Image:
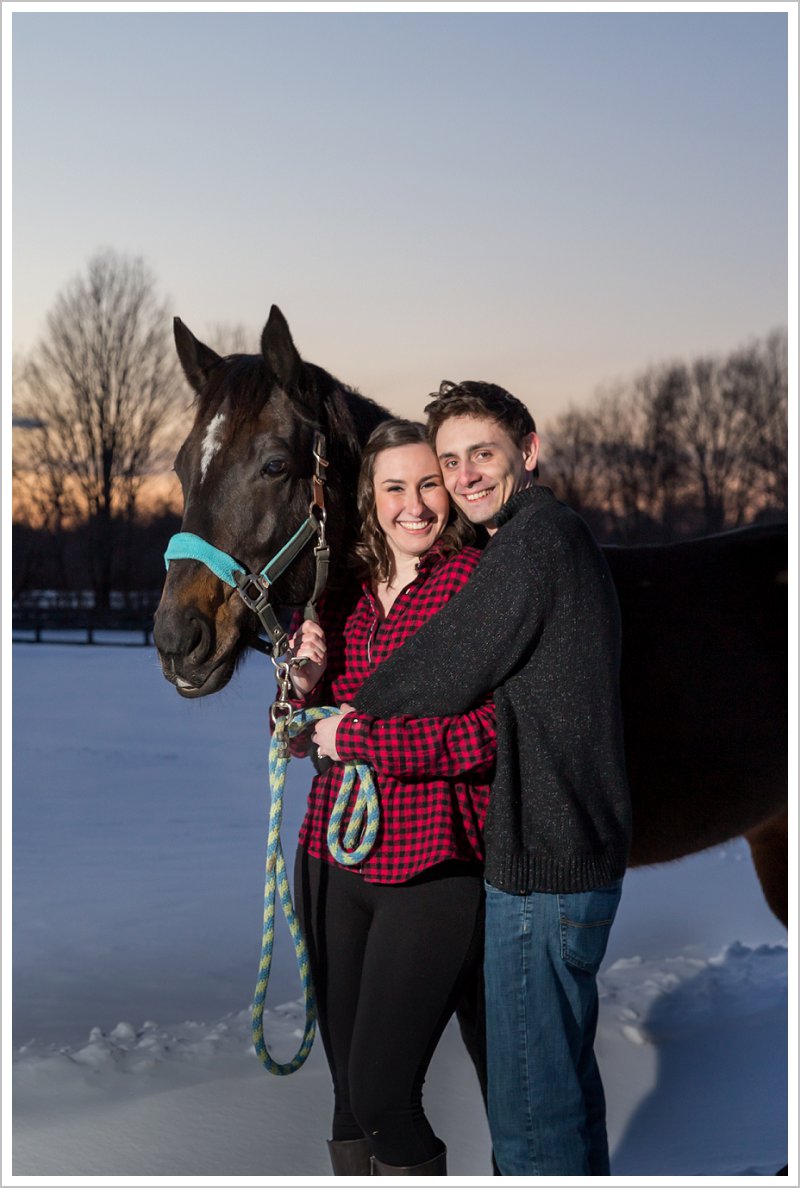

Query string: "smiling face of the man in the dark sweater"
[[436, 417, 538, 532]]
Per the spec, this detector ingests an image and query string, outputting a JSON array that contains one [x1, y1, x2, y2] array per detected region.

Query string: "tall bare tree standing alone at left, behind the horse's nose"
[[15, 252, 181, 606]]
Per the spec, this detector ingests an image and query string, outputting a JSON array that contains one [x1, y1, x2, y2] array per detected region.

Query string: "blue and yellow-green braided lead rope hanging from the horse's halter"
[[251, 693, 379, 1076]]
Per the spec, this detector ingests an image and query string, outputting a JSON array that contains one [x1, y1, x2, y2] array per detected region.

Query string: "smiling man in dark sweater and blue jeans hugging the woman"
[[320, 381, 630, 1176]]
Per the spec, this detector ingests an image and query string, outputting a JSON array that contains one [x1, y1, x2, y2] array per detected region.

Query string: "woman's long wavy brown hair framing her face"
[[355, 417, 477, 582]]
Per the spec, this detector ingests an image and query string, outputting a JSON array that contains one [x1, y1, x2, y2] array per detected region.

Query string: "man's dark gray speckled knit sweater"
[[354, 487, 630, 893]]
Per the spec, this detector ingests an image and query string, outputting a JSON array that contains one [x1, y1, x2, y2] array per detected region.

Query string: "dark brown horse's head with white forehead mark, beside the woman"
[[153, 305, 388, 697]]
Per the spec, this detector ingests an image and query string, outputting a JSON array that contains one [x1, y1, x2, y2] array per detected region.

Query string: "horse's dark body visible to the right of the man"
[[604, 524, 788, 921]]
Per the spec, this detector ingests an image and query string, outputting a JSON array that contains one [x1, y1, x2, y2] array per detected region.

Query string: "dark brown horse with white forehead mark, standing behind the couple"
[[153, 307, 787, 920]]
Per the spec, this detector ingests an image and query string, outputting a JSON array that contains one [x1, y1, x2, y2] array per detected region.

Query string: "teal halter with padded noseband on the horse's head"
[[164, 432, 330, 656]]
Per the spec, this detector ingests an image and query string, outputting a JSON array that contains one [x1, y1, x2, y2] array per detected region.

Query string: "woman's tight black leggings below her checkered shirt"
[[295, 847, 484, 1167]]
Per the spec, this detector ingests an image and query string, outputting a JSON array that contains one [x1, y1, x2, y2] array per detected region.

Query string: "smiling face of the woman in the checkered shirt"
[[372, 442, 451, 561]]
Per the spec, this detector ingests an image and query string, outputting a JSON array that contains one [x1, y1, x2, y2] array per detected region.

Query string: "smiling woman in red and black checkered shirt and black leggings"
[[280, 419, 495, 1175]]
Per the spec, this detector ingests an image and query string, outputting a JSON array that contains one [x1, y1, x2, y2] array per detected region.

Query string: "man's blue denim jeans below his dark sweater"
[[485, 879, 622, 1176]]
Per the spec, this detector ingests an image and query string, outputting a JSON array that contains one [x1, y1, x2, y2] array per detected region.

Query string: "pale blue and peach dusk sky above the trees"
[[4, 4, 796, 425]]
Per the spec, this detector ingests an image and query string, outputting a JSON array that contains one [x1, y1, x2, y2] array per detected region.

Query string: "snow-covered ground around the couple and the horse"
[[4, 644, 794, 1183]]
